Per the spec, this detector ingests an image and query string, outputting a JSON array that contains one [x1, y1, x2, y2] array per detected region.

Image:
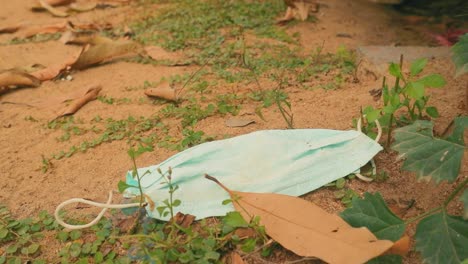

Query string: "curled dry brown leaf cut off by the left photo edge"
[[0, 69, 41, 92]]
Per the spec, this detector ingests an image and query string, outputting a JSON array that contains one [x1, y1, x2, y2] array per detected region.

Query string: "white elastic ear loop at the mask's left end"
[[54, 191, 140, 230]]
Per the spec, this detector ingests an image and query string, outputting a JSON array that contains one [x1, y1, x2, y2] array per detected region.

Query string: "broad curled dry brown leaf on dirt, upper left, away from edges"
[[71, 40, 140, 70]]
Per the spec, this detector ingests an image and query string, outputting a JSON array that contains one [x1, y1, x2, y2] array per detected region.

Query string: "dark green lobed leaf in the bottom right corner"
[[415, 211, 468, 264]]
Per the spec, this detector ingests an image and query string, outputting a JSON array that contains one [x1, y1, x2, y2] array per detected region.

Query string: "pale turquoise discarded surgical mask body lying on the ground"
[[126, 129, 382, 220]]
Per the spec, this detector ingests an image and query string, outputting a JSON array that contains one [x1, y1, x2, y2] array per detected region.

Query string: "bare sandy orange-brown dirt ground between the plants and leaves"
[[0, 0, 468, 263]]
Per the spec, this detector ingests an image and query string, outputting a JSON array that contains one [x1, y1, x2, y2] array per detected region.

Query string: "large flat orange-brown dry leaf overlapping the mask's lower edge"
[[205, 175, 393, 264]]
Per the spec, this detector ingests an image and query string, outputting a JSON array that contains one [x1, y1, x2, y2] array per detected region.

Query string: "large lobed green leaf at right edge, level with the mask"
[[392, 120, 468, 183]]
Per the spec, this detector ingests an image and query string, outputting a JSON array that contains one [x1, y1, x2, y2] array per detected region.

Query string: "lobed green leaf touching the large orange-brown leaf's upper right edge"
[[340, 193, 405, 241]]
